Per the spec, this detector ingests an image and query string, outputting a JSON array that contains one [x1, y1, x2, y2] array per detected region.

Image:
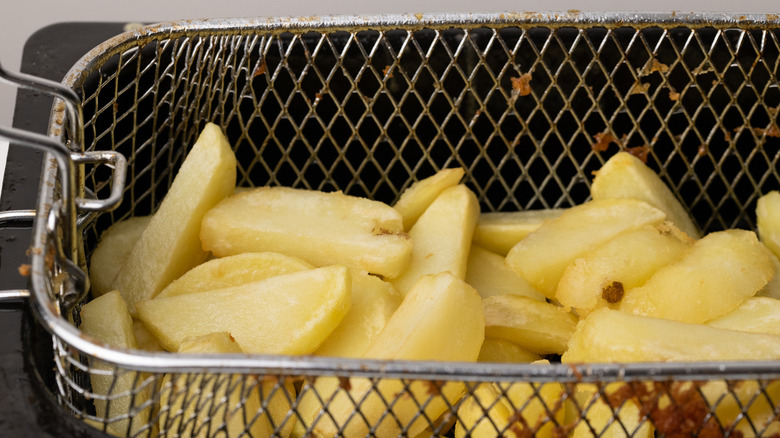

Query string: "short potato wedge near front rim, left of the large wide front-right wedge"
[[482, 295, 577, 354]]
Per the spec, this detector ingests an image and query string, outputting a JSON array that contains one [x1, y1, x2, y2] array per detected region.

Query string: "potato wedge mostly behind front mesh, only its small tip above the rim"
[[159, 332, 295, 437]]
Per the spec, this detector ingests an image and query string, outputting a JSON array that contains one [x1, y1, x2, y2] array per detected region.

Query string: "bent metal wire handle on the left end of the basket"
[[0, 65, 127, 306]]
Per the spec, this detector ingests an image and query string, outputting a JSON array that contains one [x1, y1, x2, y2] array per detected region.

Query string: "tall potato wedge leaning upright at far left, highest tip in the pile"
[[111, 123, 236, 316]]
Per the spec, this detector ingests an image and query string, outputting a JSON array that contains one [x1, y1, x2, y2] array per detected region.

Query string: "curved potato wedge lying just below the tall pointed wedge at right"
[[506, 199, 666, 298]]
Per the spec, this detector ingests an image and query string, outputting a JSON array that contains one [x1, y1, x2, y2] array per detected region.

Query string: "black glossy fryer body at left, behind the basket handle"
[[0, 23, 128, 437]]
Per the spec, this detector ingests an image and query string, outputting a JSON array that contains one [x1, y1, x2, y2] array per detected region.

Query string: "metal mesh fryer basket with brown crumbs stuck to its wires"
[[19, 13, 780, 436]]
